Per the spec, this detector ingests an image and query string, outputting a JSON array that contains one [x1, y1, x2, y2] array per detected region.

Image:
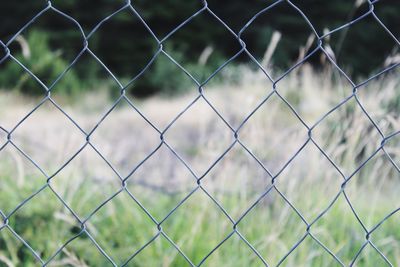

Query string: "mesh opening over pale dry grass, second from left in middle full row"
[[90, 99, 160, 177]]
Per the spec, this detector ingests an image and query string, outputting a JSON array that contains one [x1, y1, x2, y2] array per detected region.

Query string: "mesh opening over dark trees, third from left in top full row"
[[161, 12, 241, 82]]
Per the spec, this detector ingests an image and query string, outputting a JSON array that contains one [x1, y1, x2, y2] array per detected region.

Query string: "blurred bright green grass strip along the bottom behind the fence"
[[0, 166, 400, 266]]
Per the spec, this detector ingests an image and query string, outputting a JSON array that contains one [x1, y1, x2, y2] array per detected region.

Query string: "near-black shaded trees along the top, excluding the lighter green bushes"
[[0, 0, 400, 96]]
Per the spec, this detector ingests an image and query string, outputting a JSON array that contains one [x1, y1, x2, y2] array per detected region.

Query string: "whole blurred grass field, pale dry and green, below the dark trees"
[[0, 65, 400, 266]]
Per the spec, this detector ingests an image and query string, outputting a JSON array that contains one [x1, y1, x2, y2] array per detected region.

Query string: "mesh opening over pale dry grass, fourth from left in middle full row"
[[239, 94, 308, 177]]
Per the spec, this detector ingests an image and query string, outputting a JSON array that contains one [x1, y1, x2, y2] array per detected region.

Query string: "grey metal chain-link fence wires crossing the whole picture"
[[0, 0, 400, 266]]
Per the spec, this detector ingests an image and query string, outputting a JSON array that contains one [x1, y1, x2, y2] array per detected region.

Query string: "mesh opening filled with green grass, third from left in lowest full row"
[[162, 192, 233, 264]]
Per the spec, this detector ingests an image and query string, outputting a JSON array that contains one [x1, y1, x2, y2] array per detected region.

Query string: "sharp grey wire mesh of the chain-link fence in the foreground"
[[0, 0, 400, 266]]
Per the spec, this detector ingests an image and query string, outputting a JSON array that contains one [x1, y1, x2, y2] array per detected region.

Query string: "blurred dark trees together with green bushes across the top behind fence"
[[0, 0, 400, 96]]
